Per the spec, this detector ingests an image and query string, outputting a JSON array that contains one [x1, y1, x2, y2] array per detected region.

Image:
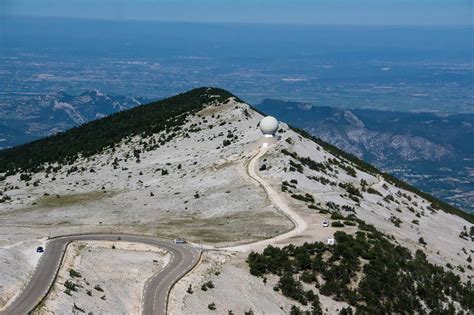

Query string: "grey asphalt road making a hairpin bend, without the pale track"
[[0, 234, 200, 315]]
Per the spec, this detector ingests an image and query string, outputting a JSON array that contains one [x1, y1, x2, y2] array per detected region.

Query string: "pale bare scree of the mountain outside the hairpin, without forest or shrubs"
[[0, 96, 472, 314]]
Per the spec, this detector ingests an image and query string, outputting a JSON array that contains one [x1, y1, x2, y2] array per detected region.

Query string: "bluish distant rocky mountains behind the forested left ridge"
[[0, 90, 146, 149]]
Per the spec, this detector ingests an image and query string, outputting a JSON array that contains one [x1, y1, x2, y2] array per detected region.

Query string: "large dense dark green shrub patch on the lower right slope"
[[247, 228, 474, 314]]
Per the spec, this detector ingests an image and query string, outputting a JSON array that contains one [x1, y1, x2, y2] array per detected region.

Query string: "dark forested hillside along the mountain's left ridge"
[[0, 87, 233, 174]]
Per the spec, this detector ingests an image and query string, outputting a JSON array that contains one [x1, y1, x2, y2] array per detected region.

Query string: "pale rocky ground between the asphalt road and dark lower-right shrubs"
[[168, 251, 347, 315]]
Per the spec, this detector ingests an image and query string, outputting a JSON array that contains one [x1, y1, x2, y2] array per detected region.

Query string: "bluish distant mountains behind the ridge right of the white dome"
[[257, 99, 474, 212]]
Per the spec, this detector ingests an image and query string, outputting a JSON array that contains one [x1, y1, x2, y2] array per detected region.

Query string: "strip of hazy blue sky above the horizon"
[[0, 0, 474, 26]]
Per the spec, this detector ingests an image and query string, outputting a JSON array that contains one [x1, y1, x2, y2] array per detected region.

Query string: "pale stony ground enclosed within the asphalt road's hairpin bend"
[[34, 241, 170, 314]]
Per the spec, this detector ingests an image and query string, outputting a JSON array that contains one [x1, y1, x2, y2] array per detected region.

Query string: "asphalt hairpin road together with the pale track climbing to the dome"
[[0, 144, 307, 315]]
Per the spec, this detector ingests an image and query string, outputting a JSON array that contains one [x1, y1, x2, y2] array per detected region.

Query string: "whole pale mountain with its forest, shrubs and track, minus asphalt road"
[[0, 88, 474, 314]]
